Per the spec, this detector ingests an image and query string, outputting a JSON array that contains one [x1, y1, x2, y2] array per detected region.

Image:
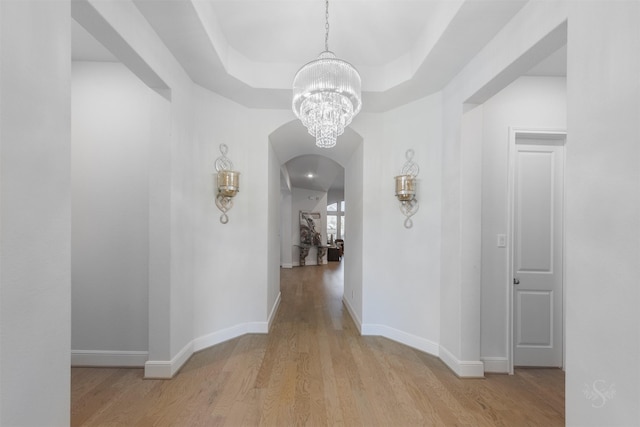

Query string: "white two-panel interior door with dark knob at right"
[[512, 138, 564, 367]]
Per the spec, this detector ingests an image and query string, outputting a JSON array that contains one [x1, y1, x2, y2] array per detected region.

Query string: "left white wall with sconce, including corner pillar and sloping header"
[[74, 0, 291, 377]]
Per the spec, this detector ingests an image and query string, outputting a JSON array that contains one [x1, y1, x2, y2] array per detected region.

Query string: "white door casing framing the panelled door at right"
[[506, 126, 567, 375]]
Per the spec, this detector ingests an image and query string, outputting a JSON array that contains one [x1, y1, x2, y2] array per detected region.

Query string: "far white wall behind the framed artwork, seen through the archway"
[[290, 187, 327, 266]]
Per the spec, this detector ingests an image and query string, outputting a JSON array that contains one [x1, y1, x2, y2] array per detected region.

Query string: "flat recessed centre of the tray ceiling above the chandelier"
[[212, 0, 442, 67]]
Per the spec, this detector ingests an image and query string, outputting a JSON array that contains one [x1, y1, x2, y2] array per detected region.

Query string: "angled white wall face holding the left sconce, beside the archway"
[[192, 85, 289, 350]]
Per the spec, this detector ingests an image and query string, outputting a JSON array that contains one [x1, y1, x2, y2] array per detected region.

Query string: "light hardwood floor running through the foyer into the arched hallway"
[[71, 262, 564, 426]]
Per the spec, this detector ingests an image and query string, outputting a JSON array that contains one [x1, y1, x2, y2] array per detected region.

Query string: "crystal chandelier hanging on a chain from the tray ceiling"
[[292, 0, 362, 148]]
